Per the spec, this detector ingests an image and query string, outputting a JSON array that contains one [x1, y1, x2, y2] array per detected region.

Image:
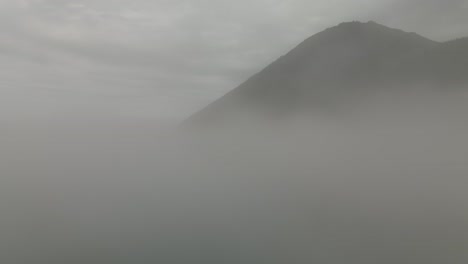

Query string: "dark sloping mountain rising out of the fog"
[[190, 21, 468, 122]]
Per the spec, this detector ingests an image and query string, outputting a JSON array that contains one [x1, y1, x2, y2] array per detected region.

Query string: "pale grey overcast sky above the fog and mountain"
[[0, 0, 468, 120]]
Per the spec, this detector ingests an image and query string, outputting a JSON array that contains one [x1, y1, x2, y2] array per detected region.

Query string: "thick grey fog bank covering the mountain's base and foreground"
[[0, 91, 468, 264]]
